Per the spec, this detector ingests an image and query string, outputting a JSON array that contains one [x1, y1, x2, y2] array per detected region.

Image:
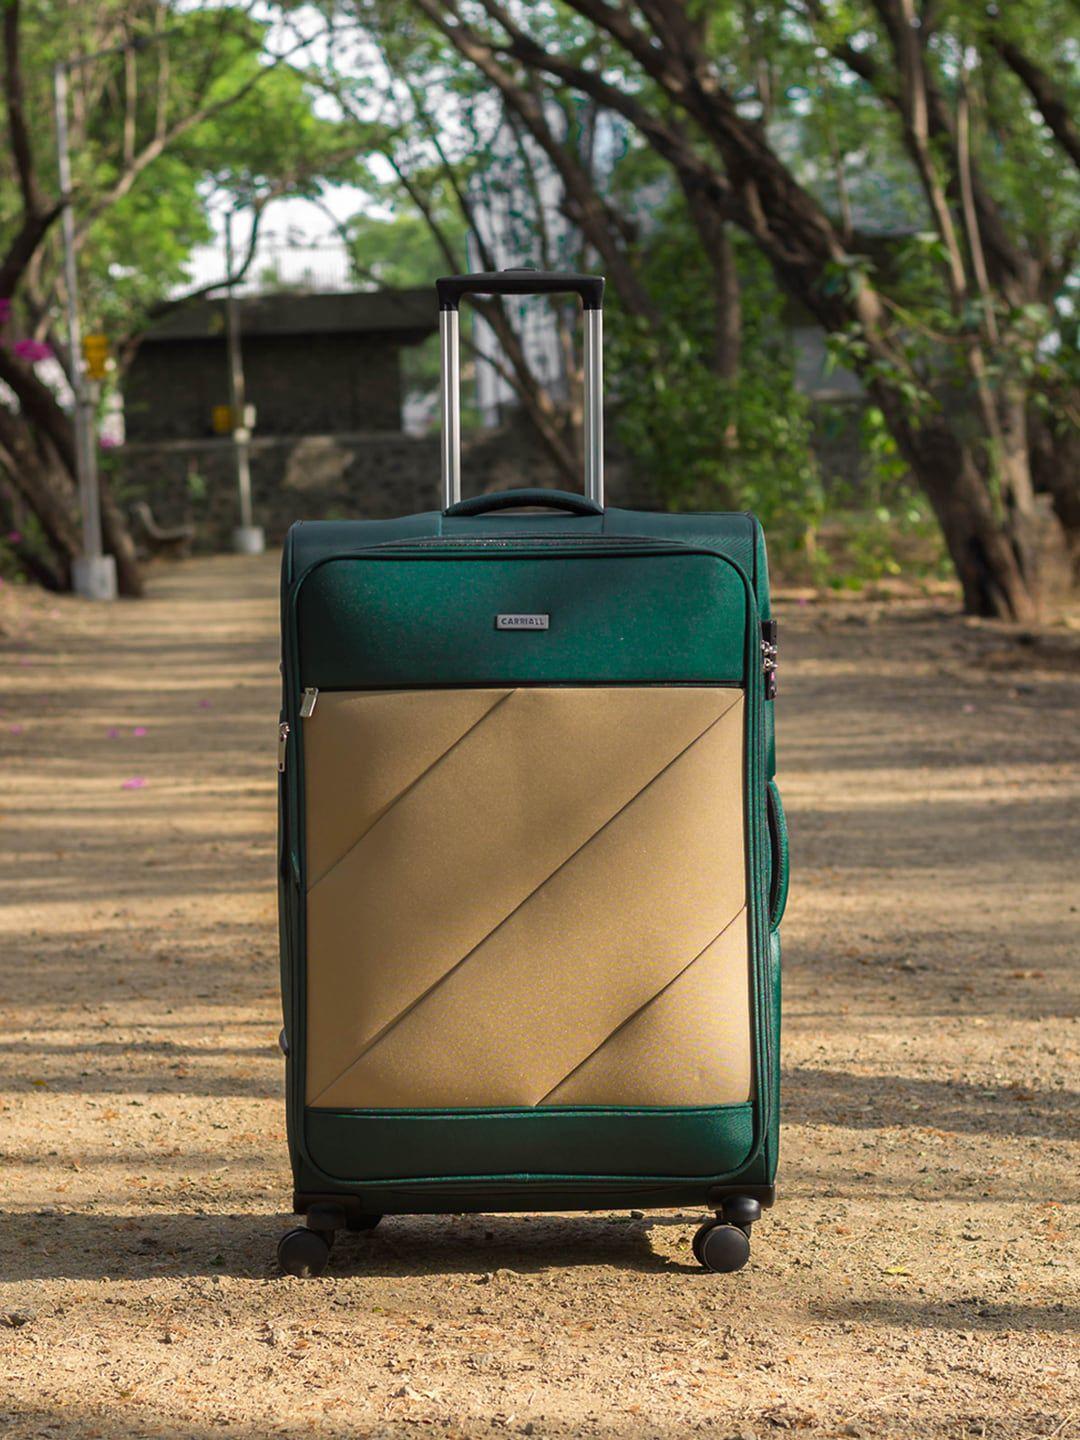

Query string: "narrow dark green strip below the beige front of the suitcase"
[[304, 1104, 753, 1182]]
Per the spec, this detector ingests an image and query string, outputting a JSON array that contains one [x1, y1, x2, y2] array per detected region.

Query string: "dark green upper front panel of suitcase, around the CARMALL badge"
[[298, 554, 746, 690]]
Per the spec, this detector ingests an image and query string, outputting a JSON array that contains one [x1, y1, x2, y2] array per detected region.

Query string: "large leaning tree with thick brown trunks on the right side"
[[391, 0, 1080, 621]]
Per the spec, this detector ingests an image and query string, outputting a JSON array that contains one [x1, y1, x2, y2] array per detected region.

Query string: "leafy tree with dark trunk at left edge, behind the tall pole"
[[0, 0, 354, 595]]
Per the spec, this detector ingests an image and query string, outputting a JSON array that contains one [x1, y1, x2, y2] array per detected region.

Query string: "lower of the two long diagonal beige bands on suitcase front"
[[308, 704, 746, 1107]]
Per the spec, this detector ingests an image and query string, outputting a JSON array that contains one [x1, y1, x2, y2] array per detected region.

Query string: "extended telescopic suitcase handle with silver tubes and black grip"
[[435, 269, 603, 510]]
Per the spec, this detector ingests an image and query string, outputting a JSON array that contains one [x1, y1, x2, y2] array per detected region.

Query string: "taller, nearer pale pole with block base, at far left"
[[52, 63, 117, 600]]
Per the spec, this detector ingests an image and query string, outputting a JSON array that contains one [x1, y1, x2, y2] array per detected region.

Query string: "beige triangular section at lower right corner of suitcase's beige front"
[[541, 910, 752, 1104]]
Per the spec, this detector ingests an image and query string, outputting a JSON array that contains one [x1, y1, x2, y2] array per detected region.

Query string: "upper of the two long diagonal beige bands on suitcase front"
[[305, 687, 742, 1096]]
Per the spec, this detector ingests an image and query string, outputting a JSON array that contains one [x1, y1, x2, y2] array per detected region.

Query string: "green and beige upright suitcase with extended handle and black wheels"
[[278, 271, 788, 1274]]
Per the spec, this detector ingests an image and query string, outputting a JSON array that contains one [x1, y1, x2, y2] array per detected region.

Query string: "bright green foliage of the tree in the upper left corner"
[[0, 0, 359, 340]]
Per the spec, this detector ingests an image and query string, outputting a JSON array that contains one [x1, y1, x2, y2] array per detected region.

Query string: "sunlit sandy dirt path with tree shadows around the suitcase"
[[0, 559, 1080, 1440]]
